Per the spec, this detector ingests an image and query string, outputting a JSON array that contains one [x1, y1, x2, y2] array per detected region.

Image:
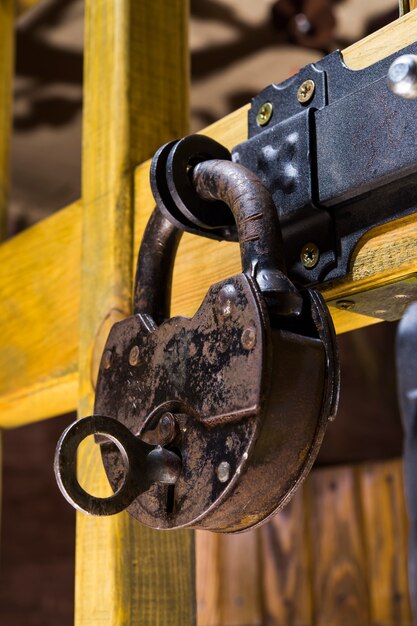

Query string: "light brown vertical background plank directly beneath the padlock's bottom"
[[219, 530, 263, 626]]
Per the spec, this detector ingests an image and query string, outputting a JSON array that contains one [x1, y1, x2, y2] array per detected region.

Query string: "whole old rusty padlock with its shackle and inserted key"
[[55, 137, 339, 532]]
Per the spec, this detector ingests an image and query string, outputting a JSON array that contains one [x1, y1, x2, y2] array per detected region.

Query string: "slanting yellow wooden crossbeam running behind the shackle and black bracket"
[[0, 12, 417, 427]]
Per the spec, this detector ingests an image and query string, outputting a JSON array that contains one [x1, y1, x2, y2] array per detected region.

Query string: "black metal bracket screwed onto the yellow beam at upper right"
[[232, 43, 417, 284]]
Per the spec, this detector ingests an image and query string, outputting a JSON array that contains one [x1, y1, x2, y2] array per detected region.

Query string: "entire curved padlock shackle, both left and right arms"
[[134, 159, 302, 325]]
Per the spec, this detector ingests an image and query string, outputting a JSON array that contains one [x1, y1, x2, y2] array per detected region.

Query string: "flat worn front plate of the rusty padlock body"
[[95, 274, 269, 528]]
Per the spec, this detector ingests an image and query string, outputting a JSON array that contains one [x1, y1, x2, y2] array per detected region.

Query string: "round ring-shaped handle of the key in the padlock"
[[54, 415, 147, 515]]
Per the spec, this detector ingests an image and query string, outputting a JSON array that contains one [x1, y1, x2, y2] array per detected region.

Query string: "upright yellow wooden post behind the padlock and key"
[[75, 0, 195, 626]]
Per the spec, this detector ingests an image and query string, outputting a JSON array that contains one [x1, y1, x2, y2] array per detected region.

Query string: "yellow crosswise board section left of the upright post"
[[0, 203, 81, 428]]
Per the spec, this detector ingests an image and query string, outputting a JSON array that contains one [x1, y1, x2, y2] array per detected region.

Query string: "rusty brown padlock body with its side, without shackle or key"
[[95, 274, 330, 532]]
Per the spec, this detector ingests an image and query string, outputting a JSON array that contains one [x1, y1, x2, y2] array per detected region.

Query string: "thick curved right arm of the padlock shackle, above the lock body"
[[192, 159, 285, 277]]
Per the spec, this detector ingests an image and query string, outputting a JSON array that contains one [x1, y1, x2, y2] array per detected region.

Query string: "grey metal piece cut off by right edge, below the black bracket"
[[396, 302, 417, 624]]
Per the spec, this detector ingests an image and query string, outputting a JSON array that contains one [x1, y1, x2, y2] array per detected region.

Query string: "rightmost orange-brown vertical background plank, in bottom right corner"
[[360, 460, 413, 626]]
